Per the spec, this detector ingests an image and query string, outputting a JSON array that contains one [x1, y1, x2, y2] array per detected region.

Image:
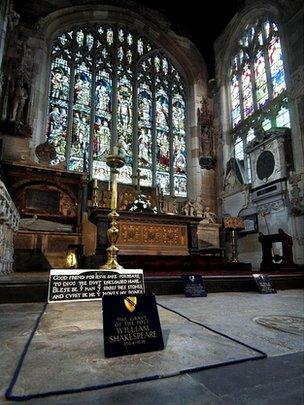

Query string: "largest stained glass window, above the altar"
[[47, 25, 187, 197]]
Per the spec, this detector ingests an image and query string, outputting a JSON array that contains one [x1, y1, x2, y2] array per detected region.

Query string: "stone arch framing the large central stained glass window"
[[29, 5, 207, 197]]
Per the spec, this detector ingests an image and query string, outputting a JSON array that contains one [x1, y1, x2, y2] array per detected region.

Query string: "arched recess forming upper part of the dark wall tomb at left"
[[3, 164, 82, 231]]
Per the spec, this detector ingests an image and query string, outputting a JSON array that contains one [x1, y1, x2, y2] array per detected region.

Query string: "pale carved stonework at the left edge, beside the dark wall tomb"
[[0, 180, 20, 276]]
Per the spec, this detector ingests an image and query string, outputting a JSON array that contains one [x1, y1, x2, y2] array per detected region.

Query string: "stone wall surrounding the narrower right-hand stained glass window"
[[214, 0, 304, 267]]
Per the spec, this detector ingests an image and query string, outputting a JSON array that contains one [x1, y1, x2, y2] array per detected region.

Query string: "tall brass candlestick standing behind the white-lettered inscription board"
[[100, 146, 125, 270]]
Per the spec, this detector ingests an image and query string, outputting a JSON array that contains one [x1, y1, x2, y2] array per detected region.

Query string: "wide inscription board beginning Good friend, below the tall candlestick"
[[48, 269, 145, 302]]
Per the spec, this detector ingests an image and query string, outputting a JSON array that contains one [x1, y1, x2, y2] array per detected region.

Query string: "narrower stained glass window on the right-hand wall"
[[229, 18, 290, 181]]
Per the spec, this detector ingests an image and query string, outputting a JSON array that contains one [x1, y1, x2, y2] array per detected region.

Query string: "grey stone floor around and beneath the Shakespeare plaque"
[[0, 290, 304, 404]]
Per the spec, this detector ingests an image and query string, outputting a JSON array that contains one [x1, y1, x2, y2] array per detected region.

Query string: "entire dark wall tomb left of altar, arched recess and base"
[[1, 162, 86, 271]]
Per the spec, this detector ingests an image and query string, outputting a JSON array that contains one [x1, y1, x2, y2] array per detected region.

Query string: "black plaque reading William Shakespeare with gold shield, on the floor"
[[102, 293, 164, 357]]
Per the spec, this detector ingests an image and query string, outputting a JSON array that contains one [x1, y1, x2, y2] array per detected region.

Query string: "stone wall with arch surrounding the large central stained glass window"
[[0, 0, 216, 210]]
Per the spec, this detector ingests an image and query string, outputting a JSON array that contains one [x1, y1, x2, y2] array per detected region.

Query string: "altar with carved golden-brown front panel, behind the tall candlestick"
[[89, 207, 201, 256]]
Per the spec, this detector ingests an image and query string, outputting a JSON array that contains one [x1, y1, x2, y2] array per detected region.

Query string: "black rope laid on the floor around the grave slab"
[[5, 303, 267, 401]]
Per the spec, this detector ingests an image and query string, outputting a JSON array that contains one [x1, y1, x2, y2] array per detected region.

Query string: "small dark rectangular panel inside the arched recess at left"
[[26, 189, 60, 214]]
